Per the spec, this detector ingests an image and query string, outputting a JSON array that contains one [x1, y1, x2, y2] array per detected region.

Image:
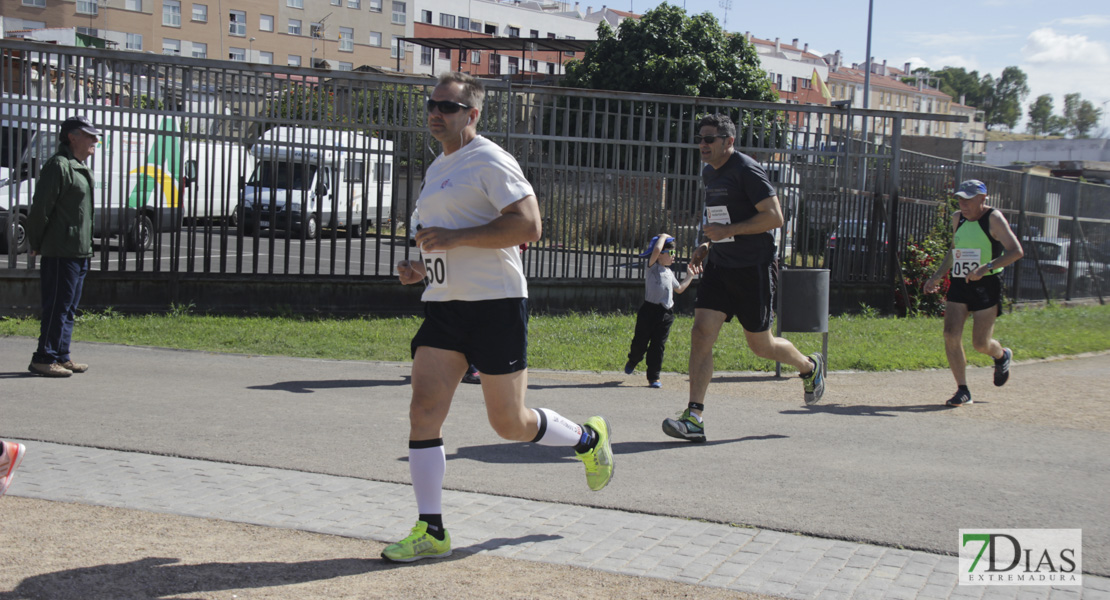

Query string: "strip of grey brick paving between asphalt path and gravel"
[[9, 441, 1110, 600]]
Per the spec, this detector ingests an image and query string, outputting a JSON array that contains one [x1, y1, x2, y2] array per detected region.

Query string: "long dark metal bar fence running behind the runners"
[[0, 40, 1110, 308]]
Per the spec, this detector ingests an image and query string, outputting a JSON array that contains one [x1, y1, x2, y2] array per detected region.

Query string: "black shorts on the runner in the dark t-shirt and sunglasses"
[[694, 261, 778, 333]]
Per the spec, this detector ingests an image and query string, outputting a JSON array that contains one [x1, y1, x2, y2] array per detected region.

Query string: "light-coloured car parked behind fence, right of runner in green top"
[[1006, 237, 1110, 299]]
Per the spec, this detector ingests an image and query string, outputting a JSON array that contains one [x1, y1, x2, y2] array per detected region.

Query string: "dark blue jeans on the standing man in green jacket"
[[31, 256, 89, 365]]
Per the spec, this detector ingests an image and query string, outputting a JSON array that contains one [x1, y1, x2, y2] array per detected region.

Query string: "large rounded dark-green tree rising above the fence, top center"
[[563, 3, 778, 102]]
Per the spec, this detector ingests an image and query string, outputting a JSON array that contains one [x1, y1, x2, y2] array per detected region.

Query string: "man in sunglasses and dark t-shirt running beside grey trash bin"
[[663, 114, 825, 441]]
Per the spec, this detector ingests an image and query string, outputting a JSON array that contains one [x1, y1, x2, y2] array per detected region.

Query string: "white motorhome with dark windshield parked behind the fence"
[[239, 126, 393, 240]]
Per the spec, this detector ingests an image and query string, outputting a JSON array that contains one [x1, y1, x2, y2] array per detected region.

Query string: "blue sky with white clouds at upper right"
[[630, 0, 1110, 131]]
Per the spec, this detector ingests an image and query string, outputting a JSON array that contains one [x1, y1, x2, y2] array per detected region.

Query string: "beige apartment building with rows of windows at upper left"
[[0, 0, 414, 72]]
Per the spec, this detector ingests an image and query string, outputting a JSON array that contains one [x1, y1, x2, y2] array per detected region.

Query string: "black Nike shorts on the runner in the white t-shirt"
[[411, 298, 528, 375]]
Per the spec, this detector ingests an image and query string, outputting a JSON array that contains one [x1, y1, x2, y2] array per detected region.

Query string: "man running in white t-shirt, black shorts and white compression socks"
[[382, 72, 613, 562]]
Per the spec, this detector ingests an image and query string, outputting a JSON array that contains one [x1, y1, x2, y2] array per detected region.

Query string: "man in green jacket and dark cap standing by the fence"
[[27, 116, 100, 377]]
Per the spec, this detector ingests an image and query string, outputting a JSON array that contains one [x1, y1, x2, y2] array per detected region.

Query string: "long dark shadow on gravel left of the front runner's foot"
[[0, 557, 379, 600]]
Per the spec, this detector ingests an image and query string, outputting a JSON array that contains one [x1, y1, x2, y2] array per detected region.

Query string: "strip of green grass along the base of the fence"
[[0, 306, 1110, 373]]
